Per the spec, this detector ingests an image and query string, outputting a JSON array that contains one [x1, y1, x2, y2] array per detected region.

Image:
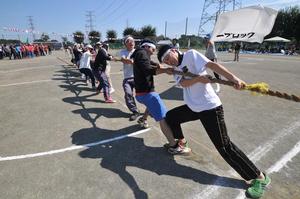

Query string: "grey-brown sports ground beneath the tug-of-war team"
[[0, 51, 300, 199]]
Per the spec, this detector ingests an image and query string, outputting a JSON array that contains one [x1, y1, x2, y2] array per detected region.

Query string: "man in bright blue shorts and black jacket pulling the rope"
[[131, 40, 190, 154]]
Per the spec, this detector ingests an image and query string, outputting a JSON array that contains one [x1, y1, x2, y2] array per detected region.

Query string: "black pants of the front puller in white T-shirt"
[[166, 105, 260, 181]]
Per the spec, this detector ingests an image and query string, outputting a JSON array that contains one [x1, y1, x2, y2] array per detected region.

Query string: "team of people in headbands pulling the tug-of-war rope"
[[61, 36, 271, 198]]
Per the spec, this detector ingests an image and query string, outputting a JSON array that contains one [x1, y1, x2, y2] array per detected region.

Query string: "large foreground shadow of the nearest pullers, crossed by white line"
[[72, 126, 245, 199]]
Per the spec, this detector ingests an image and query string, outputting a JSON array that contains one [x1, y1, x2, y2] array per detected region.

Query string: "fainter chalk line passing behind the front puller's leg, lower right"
[[194, 121, 300, 199]]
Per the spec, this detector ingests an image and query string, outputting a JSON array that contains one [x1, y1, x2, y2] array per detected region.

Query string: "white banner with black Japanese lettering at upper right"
[[211, 6, 278, 43]]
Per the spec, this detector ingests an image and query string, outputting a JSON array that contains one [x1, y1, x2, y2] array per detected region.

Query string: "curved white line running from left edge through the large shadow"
[[0, 128, 151, 162]]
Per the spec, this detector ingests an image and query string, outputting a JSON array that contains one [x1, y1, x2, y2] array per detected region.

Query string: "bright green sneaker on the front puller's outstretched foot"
[[246, 174, 271, 198]]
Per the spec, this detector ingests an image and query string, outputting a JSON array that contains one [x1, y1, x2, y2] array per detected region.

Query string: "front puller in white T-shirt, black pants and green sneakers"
[[157, 45, 271, 198]]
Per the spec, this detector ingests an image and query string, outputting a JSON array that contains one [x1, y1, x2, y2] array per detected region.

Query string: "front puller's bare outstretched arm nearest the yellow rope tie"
[[206, 62, 246, 89]]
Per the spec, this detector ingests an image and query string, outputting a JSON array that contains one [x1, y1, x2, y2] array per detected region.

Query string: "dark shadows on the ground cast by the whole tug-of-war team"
[[56, 64, 245, 199]]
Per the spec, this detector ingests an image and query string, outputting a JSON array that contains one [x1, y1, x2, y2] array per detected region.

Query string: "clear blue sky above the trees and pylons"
[[0, 0, 300, 40]]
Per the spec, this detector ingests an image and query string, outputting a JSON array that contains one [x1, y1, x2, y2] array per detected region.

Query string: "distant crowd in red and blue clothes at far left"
[[0, 43, 52, 60]]
